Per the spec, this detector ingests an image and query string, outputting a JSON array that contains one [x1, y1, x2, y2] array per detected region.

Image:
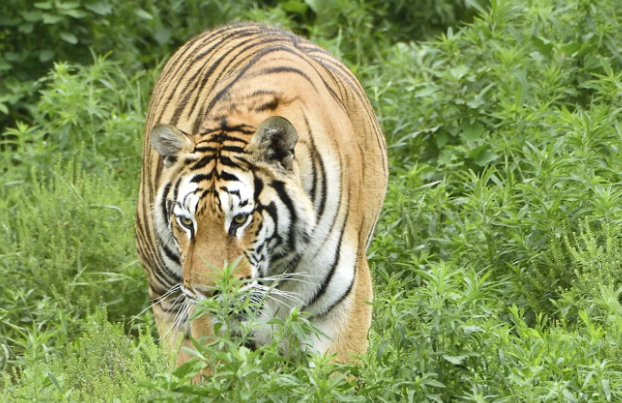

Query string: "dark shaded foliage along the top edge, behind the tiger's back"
[[0, 0, 473, 132]]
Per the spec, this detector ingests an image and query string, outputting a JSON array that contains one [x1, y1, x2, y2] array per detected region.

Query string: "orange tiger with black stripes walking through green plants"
[[135, 23, 388, 365]]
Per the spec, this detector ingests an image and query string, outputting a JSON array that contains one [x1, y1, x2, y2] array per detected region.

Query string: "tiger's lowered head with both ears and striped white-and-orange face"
[[151, 116, 315, 312]]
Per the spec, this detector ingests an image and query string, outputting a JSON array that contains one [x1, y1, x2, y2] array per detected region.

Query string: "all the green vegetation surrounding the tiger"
[[0, 0, 622, 403]]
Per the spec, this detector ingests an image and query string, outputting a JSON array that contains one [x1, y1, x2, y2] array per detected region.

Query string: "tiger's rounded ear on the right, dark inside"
[[251, 116, 298, 171]]
